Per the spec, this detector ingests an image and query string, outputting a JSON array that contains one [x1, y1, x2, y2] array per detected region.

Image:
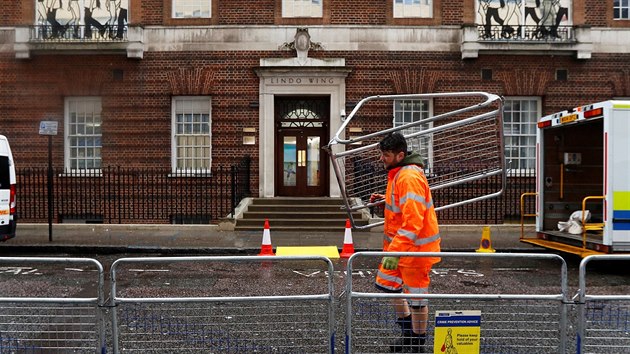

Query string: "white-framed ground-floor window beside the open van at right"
[[503, 98, 540, 170]]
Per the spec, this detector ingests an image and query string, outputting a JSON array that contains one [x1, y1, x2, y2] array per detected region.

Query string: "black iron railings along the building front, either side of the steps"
[[16, 156, 535, 224]]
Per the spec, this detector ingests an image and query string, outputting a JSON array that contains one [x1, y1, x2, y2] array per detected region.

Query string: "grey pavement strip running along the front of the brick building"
[[0, 223, 541, 256]]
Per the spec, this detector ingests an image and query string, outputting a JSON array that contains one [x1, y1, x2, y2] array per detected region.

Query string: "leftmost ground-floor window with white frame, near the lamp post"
[[64, 97, 102, 171]]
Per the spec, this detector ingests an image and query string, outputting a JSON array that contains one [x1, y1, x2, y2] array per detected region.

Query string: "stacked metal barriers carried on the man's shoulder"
[[325, 92, 506, 229]]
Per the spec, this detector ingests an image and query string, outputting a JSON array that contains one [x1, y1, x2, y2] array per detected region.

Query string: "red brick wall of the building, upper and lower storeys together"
[[0, 0, 630, 224]]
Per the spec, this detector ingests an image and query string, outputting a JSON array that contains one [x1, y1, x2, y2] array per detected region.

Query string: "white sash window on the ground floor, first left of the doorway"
[[172, 97, 212, 173]]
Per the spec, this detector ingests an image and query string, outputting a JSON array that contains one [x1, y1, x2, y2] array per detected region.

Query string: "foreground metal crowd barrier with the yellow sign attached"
[[346, 252, 569, 354]]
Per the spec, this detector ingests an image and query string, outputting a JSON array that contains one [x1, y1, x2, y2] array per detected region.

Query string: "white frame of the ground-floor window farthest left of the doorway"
[[64, 96, 103, 173]]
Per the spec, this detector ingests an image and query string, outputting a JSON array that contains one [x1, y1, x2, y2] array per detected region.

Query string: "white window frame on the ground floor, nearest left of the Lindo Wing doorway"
[[171, 96, 212, 175]]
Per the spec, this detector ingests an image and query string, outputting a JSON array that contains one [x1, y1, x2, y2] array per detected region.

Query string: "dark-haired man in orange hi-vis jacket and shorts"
[[370, 133, 440, 353]]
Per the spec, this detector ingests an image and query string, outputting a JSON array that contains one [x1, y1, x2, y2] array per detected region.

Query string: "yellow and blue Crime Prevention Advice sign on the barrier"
[[433, 310, 481, 354]]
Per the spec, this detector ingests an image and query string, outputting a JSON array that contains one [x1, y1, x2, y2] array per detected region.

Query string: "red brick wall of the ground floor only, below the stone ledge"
[[0, 52, 630, 168]]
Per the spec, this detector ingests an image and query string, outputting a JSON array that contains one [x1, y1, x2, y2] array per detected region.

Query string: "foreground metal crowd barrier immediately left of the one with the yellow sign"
[[111, 256, 335, 353]]
